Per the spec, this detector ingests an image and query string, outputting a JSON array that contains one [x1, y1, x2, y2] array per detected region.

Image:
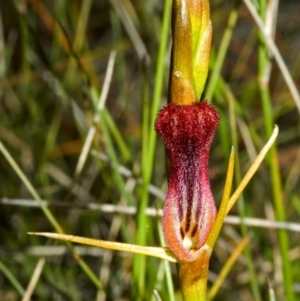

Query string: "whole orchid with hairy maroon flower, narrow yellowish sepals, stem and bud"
[[28, 0, 278, 301]]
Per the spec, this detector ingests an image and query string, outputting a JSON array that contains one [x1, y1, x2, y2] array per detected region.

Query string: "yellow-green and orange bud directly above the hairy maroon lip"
[[170, 0, 212, 105]]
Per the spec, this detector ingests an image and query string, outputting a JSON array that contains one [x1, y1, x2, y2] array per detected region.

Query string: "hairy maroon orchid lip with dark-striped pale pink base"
[[155, 102, 220, 261]]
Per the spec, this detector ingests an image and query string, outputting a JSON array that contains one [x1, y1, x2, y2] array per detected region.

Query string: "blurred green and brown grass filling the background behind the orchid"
[[0, 0, 300, 301]]
